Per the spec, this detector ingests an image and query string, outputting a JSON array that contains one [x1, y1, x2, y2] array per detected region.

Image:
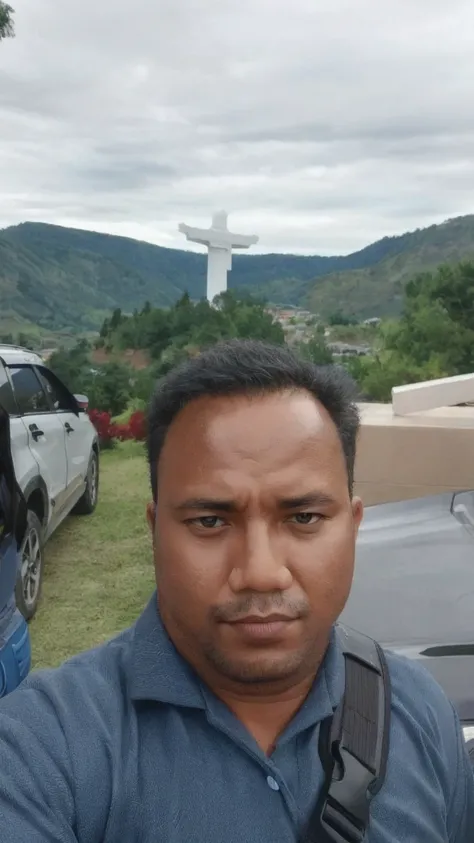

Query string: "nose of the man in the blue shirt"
[[229, 523, 293, 592]]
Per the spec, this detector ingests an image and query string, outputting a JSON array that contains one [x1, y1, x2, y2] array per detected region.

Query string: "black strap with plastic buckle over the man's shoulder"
[[303, 626, 391, 843]]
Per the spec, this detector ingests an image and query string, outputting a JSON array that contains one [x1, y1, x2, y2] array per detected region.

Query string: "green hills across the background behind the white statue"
[[0, 216, 474, 330]]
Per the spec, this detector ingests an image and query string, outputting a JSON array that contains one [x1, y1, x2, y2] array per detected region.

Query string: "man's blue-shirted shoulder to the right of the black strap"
[[369, 652, 474, 843]]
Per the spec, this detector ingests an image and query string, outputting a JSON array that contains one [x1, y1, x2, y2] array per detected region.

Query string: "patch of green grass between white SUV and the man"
[[30, 442, 154, 668]]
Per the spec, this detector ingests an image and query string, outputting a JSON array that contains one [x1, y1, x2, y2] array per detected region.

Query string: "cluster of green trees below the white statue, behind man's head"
[[71, 292, 285, 416]]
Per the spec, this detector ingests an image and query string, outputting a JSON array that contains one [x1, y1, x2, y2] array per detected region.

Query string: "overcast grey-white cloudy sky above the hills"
[[0, 0, 474, 254]]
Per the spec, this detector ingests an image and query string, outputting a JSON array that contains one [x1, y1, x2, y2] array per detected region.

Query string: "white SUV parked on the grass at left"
[[0, 344, 99, 620]]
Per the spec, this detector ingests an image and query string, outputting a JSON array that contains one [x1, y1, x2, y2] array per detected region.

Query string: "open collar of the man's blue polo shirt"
[[129, 592, 344, 724]]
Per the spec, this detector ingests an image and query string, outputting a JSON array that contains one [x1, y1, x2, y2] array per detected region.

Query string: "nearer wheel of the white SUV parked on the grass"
[[15, 509, 44, 621]]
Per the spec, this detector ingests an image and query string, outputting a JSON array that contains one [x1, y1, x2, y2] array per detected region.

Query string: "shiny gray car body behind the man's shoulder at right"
[[341, 491, 474, 722]]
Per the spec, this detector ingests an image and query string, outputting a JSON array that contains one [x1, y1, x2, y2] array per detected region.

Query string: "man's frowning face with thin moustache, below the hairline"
[[149, 392, 362, 684]]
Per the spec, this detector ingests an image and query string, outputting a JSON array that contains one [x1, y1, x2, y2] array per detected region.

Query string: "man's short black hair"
[[148, 340, 359, 501]]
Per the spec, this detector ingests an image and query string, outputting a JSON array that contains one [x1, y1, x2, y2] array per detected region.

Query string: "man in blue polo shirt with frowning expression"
[[0, 342, 474, 843]]
